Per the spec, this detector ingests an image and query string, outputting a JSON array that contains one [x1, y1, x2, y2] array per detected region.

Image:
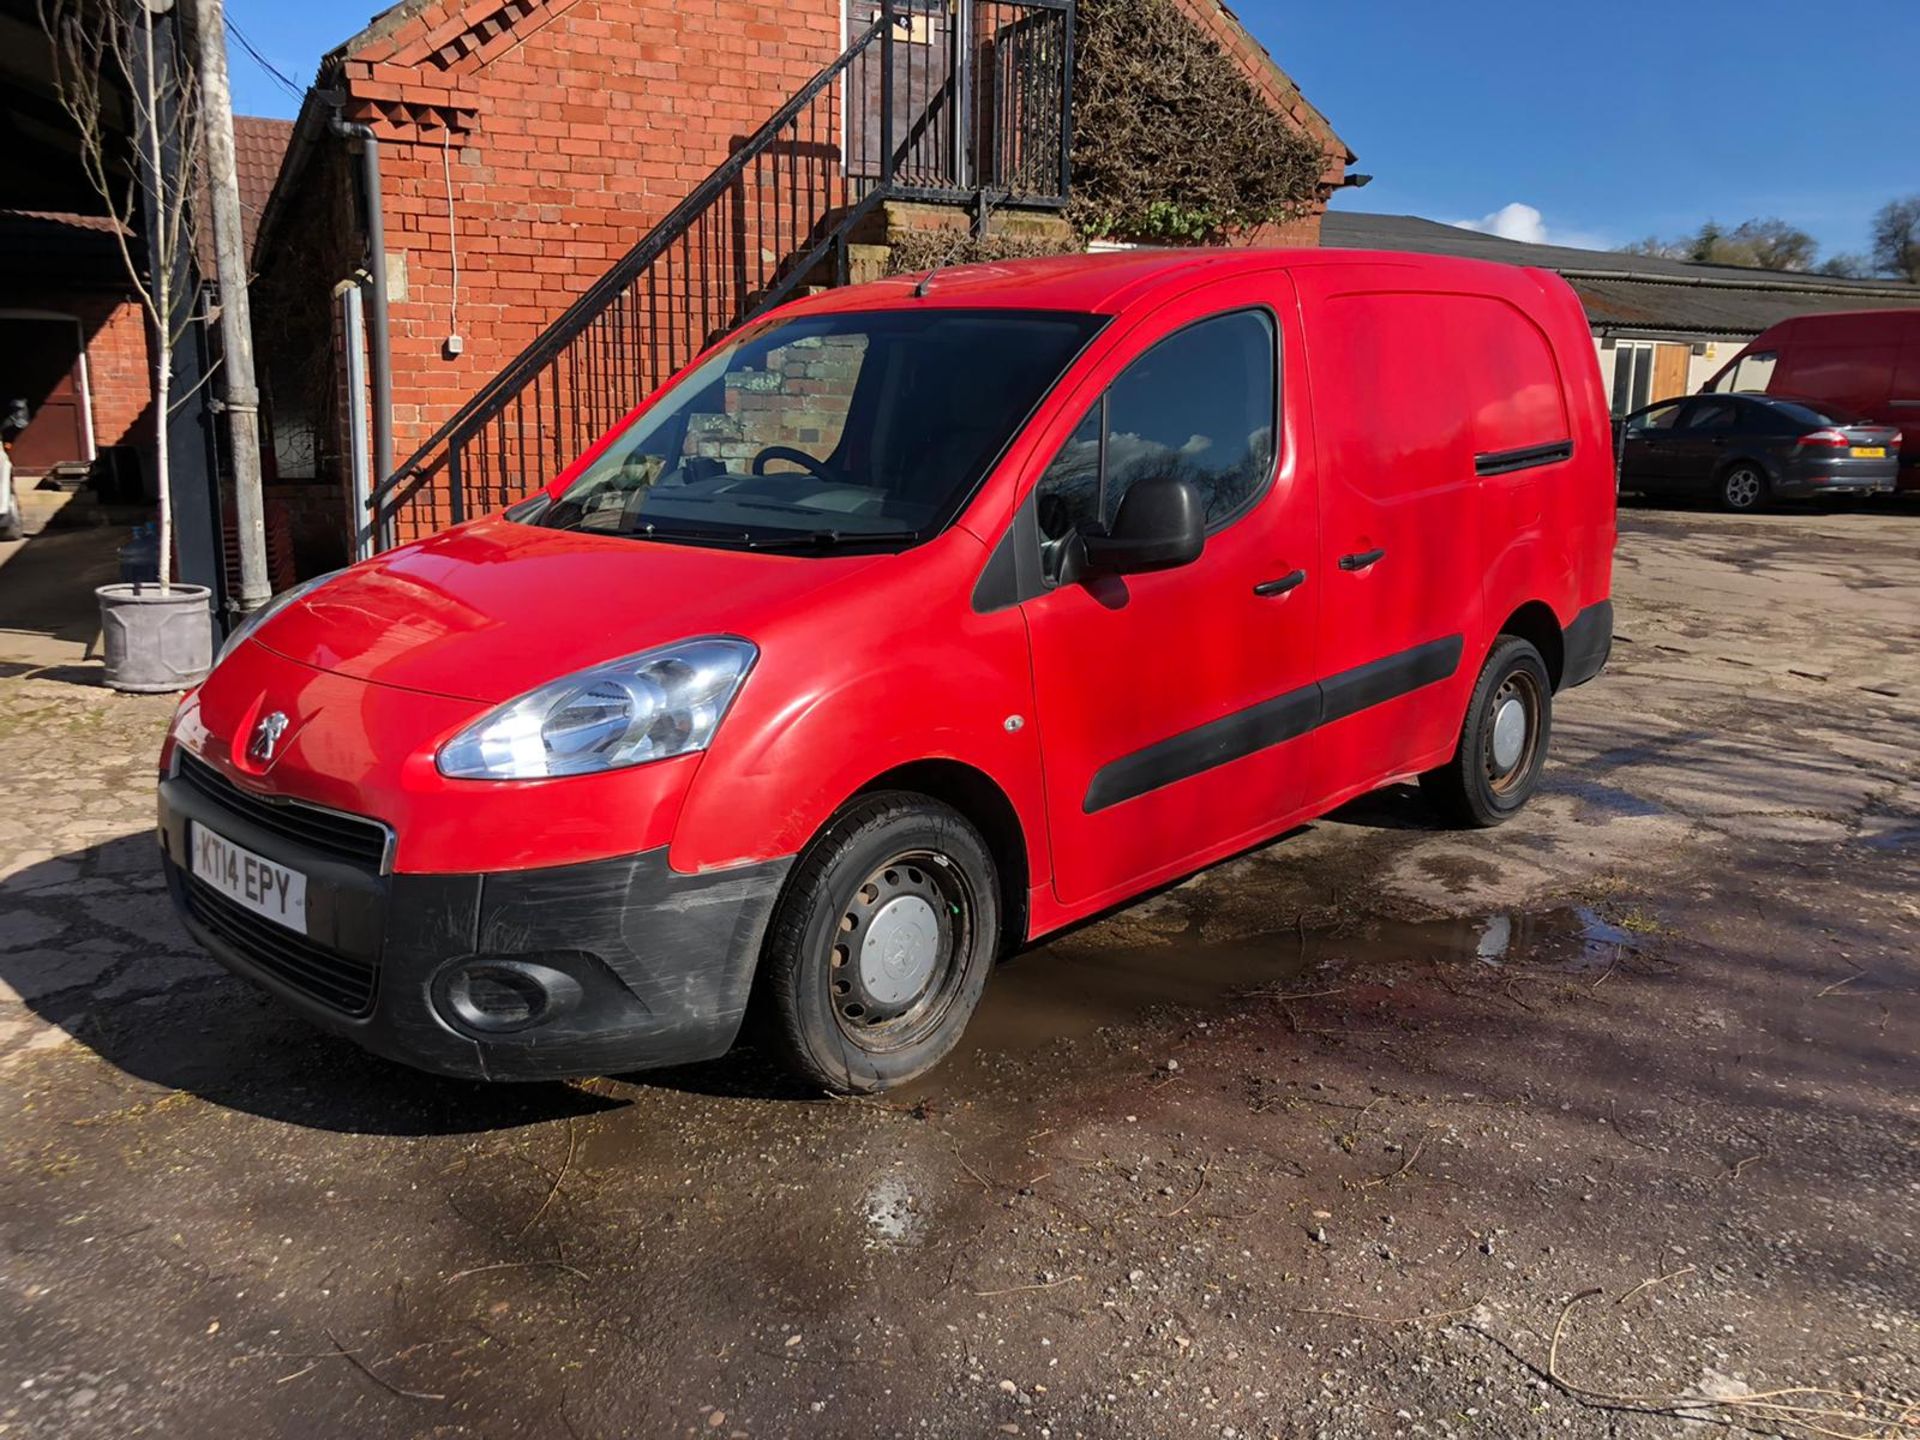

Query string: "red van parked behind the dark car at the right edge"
[[1707, 307, 1920, 492]]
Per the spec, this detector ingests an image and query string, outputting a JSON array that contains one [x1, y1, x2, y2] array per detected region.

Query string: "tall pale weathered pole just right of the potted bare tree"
[[190, 0, 273, 614]]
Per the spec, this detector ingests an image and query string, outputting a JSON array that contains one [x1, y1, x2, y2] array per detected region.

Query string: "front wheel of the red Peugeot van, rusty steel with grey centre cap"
[[762, 791, 1000, 1094]]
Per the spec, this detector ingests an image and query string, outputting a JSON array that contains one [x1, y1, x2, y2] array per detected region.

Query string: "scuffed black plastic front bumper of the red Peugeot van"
[[159, 776, 793, 1079]]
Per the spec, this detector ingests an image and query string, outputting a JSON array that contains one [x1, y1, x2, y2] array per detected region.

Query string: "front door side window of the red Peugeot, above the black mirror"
[[1039, 309, 1279, 540]]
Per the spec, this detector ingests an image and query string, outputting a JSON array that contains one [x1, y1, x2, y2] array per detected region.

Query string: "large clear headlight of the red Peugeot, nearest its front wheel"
[[438, 637, 760, 780]]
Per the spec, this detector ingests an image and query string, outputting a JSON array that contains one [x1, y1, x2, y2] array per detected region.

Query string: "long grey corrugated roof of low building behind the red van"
[[1321, 211, 1920, 336]]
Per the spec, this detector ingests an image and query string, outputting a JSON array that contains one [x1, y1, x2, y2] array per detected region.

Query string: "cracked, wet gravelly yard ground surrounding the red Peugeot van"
[[0, 505, 1920, 1440]]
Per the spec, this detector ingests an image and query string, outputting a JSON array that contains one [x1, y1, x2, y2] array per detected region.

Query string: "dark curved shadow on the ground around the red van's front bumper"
[[0, 831, 624, 1135]]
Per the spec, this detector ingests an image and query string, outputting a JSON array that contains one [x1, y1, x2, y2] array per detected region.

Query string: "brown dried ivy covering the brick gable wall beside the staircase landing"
[[1069, 0, 1327, 242]]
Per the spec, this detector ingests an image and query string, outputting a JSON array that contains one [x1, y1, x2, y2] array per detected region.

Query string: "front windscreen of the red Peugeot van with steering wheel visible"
[[524, 309, 1102, 549]]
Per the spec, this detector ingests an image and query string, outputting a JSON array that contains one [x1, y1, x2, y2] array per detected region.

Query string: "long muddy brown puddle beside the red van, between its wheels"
[[962, 906, 1649, 1054]]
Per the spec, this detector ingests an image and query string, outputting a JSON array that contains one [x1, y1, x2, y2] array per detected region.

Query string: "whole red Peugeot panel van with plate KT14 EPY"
[[159, 252, 1615, 1091]]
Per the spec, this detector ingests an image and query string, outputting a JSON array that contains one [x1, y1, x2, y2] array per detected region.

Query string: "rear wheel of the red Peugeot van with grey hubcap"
[[1421, 636, 1553, 829]]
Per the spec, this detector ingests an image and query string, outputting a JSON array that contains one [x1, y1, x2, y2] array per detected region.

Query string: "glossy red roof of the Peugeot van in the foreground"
[[791, 248, 1532, 315]]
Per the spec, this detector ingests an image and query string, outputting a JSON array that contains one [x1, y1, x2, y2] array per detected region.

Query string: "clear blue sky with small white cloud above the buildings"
[[217, 0, 1920, 263]]
